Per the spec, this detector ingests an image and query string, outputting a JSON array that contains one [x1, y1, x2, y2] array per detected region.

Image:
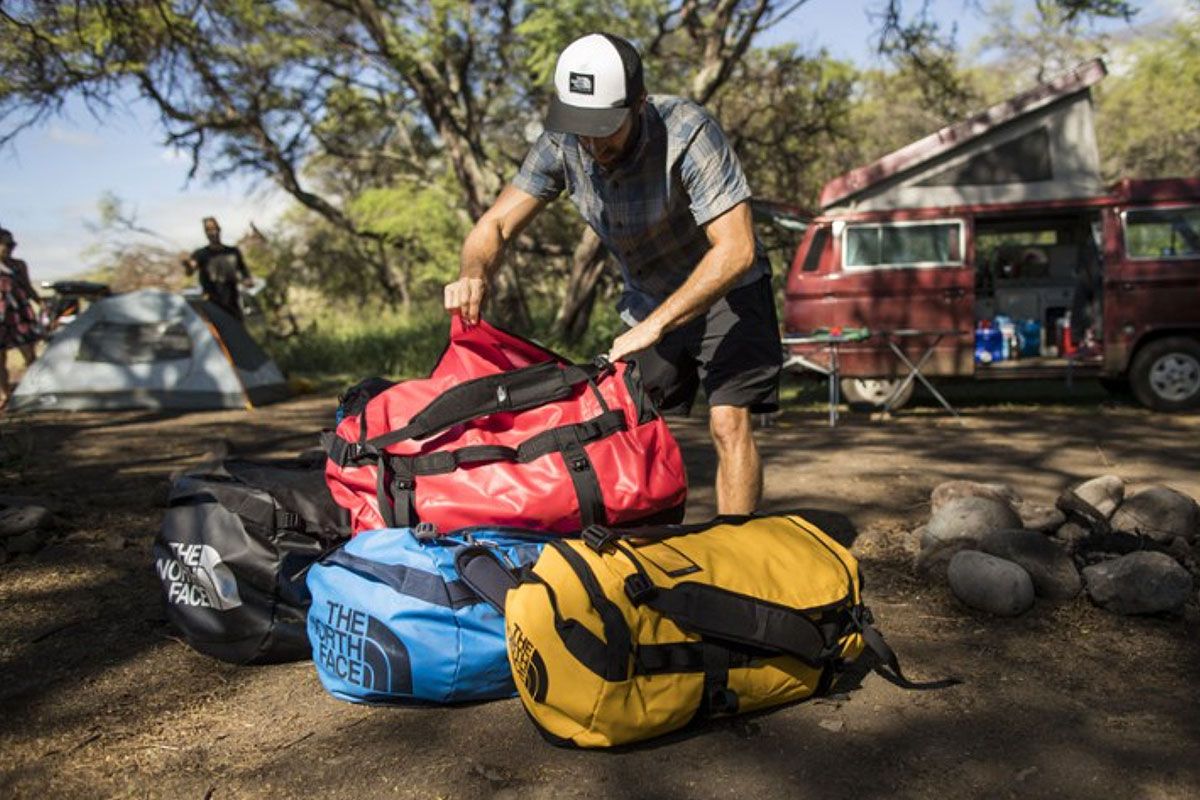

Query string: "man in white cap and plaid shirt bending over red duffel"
[[445, 34, 782, 513]]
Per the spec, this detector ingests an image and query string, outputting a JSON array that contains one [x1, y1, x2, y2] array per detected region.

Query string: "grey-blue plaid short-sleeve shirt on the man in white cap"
[[512, 96, 770, 320]]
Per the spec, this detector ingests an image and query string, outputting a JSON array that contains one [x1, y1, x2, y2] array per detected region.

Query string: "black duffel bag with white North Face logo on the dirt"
[[154, 453, 349, 663]]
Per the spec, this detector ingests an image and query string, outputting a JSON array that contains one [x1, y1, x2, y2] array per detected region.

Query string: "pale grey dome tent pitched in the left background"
[[10, 290, 287, 411]]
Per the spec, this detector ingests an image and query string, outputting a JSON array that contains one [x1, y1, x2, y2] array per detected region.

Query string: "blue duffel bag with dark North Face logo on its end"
[[308, 528, 547, 704]]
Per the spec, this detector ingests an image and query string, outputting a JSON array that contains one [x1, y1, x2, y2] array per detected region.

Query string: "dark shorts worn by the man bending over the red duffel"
[[630, 276, 784, 415]]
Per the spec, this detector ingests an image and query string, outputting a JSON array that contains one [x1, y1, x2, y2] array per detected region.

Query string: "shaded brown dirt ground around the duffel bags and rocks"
[[0, 387, 1200, 800]]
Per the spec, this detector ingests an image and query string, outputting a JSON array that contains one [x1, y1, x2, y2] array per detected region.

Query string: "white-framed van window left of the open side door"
[[841, 219, 962, 270]]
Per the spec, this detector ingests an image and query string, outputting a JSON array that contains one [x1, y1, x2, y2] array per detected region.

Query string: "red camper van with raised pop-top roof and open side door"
[[785, 61, 1200, 410]]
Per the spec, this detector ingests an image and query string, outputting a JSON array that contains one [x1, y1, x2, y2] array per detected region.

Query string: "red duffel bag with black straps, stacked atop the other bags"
[[324, 315, 688, 534]]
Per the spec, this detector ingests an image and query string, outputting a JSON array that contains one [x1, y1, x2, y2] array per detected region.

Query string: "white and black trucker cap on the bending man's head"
[[546, 34, 644, 137]]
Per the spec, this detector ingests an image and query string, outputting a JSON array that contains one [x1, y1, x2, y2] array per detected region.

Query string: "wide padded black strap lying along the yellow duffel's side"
[[635, 583, 829, 668]]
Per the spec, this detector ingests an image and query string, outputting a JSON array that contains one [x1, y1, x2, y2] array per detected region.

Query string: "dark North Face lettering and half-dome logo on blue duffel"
[[308, 601, 413, 694]]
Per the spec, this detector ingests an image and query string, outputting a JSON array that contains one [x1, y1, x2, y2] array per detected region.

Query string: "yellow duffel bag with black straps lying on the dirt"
[[458, 516, 945, 747]]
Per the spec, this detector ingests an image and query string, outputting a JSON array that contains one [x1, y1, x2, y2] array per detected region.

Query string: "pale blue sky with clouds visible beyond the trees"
[[0, 0, 1187, 281]]
